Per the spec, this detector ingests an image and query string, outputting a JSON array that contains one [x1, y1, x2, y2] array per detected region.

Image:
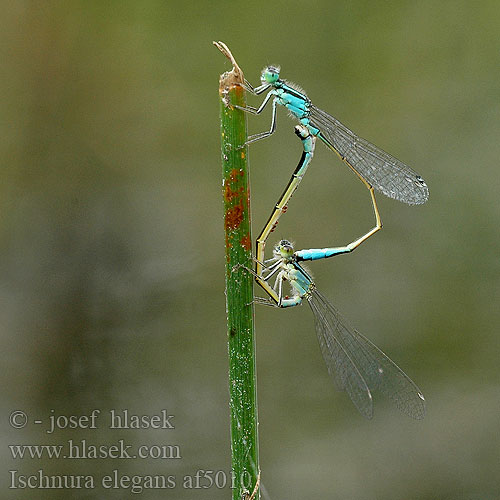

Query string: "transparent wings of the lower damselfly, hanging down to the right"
[[308, 289, 425, 419]]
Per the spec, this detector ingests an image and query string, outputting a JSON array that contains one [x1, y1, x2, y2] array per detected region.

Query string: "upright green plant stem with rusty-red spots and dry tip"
[[216, 42, 259, 500]]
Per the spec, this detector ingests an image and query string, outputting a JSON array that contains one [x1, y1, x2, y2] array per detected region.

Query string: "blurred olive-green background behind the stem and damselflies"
[[0, 0, 500, 500]]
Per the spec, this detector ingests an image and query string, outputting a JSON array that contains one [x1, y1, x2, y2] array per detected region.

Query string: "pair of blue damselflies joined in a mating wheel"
[[239, 66, 429, 419]]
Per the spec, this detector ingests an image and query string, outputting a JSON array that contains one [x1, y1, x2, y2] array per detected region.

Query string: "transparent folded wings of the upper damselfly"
[[309, 105, 429, 205]]
